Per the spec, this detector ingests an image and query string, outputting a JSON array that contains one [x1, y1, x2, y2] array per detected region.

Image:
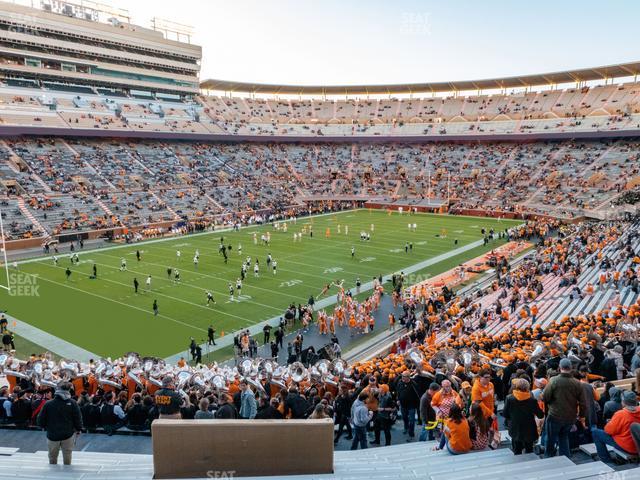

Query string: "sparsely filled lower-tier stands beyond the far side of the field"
[[0, 138, 640, 238]]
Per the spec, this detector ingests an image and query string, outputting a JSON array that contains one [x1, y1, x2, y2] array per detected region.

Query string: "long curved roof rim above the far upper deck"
[[200, 62, 640, 95]]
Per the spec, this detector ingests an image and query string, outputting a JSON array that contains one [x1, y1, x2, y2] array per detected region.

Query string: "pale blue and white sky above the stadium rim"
[[126, 0, 640, 85]]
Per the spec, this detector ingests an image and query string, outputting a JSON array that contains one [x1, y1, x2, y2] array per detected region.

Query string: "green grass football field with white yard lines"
[[0, 210, 519, 357]]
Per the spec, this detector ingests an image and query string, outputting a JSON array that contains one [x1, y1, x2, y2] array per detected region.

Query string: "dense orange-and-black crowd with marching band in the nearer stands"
[[0, 217, 640, 462]]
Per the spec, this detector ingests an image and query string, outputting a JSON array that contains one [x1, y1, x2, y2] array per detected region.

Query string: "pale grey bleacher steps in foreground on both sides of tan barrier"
[[0, 442, 624, 480]]
